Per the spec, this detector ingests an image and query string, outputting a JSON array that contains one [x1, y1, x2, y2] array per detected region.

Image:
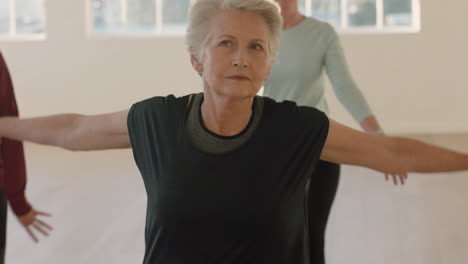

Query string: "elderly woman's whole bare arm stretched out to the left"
[[0, 110, 130, 150]]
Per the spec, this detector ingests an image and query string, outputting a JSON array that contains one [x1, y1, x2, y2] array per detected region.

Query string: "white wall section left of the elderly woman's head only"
[[0, 0, 200, 116]]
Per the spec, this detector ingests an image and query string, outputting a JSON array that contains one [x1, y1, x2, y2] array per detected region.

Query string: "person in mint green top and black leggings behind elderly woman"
[[263, 0, 397, 264]]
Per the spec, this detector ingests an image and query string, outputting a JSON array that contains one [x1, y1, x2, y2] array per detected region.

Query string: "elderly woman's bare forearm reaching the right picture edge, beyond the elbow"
[[392, 137, 468, 172]]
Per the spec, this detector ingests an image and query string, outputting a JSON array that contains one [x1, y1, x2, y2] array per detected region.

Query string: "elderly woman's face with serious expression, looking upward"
[[192, 10, 271, 98]]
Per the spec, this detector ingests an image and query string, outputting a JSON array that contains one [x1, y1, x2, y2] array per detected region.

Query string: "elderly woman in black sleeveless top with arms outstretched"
[[0, 0, 468, 264]]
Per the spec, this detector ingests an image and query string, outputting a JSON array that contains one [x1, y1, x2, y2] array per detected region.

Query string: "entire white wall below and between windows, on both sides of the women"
[[0, 0, 468, 133]]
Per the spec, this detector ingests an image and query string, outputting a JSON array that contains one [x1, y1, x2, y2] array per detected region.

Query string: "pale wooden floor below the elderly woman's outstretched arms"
[[3, 135, 468, 264]]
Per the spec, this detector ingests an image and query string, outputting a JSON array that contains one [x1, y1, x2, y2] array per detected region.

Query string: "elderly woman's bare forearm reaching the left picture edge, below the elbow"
[[0, 114, 80, 148]]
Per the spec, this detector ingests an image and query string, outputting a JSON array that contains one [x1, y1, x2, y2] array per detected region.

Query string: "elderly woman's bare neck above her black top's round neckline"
[[201, 90, 255, 136]]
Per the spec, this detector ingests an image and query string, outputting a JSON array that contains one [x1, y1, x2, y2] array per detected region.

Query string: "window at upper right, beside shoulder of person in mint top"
[[299, 0, 420, 33]]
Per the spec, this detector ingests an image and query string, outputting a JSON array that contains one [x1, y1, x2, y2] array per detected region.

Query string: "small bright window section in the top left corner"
[[0, 0, 45, 37]]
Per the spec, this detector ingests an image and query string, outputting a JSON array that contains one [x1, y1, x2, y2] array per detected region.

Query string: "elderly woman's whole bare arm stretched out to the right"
[[321, 120, 468, 174]]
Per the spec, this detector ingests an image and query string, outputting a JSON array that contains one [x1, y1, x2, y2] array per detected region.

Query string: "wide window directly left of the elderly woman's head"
[[89, 0, 195, 35]]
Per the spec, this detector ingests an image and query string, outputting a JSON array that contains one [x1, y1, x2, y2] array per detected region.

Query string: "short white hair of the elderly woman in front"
[[185, 0, 283, 61]]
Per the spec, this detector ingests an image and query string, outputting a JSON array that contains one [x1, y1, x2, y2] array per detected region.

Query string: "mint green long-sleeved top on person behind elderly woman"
[[263, 17, 373, 123]]
